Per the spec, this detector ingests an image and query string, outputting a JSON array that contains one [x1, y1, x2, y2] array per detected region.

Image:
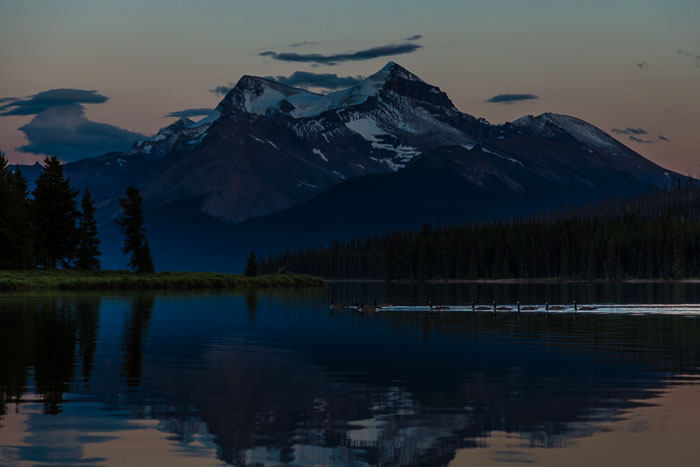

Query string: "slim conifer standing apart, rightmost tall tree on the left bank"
[[117, 186, 155, 273]]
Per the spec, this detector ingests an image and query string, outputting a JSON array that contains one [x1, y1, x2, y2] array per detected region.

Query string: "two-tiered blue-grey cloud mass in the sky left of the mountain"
[[0, 89, 143, 161]]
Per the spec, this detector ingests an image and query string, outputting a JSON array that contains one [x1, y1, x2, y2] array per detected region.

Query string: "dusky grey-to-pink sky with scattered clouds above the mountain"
[[0, 0, 700, 176]]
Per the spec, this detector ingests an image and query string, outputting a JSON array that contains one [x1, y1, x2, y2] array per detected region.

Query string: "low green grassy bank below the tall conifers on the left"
[[0, 270, 325, 292]]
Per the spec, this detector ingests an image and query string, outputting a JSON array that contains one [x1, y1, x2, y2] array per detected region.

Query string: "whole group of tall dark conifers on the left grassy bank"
[[0, 152, 155, 273]]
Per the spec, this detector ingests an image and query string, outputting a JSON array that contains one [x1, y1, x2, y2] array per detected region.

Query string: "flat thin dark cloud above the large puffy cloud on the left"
[[0, 88, 108, 115]]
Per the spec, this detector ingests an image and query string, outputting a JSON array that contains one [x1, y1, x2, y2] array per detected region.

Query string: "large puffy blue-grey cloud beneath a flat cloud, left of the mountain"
[[17, 103, 144, 162]]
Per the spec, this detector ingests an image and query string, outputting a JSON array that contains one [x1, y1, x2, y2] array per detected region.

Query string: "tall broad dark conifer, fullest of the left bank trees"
[[32, 156, 78, 269]]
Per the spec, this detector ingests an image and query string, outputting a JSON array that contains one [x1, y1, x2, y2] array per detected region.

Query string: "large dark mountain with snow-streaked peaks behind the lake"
[[19, 62, 678, 271]]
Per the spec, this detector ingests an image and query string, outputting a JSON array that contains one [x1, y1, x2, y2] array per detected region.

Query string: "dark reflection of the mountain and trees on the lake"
[[0, 290, 700, 465]]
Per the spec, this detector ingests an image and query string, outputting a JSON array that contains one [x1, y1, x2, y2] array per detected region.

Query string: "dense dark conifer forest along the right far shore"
[[261, 179, 700, 281]]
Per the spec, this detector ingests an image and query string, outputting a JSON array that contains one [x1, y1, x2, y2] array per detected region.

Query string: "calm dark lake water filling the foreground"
[[0, 283, 700, 466]]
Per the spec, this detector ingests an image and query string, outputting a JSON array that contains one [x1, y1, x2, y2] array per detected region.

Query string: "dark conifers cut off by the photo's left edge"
[[0, 151, 33, 269]]
